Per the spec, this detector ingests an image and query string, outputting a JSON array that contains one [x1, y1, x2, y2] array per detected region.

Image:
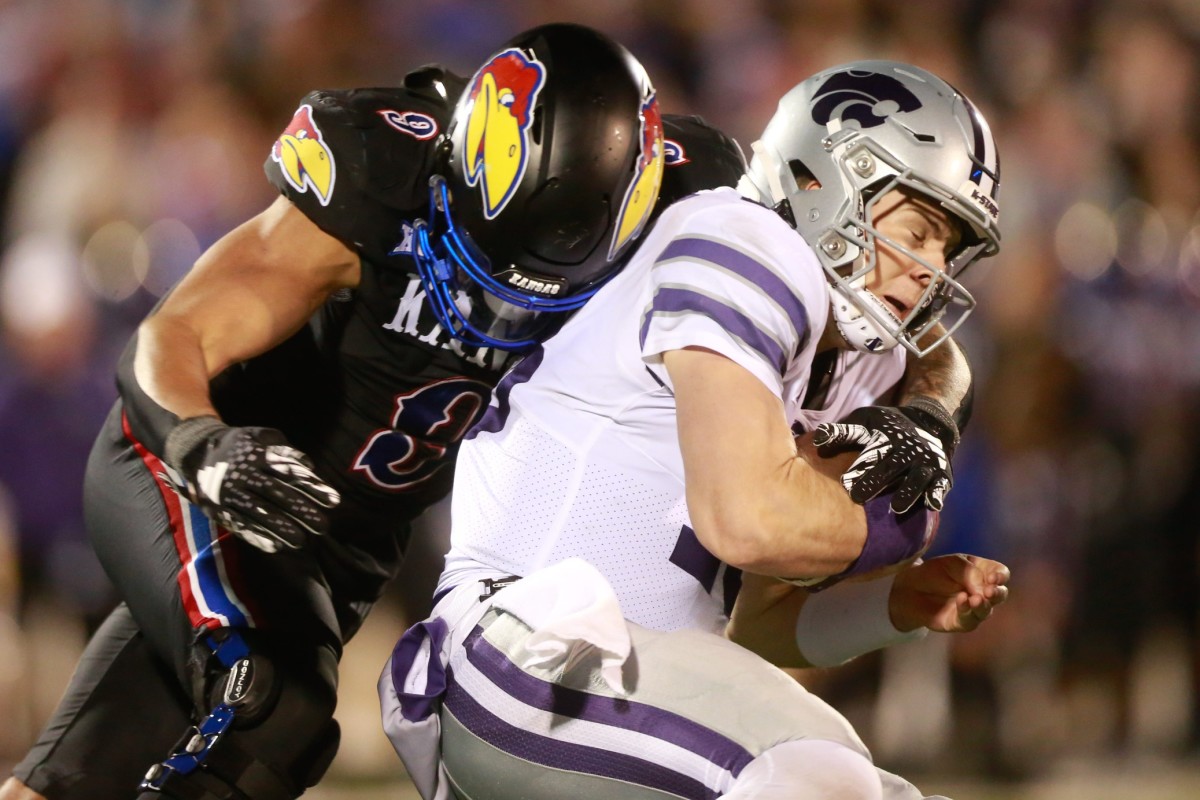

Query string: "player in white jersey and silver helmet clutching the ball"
[[380, 61, 1008, 800]]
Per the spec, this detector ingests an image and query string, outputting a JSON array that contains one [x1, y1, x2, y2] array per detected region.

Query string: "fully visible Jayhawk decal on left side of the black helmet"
[[462, 48, 546, 219]]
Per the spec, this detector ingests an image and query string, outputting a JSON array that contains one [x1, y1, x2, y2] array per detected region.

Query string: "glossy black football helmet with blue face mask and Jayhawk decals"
[[414, 24, 664, 350]]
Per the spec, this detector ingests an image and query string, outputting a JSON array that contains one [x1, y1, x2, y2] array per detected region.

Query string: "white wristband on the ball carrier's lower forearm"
[[796, 576, 929, 667]]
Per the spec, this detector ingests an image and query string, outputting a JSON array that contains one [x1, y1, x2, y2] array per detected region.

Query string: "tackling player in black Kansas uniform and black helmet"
[[0, 25, 744, 800]]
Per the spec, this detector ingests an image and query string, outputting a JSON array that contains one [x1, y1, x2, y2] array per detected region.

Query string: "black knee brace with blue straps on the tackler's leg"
[[140, 631, 341, 800]]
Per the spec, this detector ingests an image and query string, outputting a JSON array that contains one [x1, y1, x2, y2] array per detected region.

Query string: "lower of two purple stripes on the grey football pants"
[[445, 670, 719, 800]]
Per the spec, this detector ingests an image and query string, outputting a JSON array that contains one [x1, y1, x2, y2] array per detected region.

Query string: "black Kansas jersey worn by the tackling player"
[[214, 67, 743, 568]]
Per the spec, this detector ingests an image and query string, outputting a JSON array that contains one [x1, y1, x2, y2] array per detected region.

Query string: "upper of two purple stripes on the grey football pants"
[[463, 627, 754, 777]]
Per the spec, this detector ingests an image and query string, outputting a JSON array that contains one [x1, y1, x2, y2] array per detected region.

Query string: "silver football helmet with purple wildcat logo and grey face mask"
[[738, 61, 1000, 355]]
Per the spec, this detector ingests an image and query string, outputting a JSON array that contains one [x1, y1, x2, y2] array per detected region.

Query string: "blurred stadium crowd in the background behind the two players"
[[0, 0, 1200, 796]]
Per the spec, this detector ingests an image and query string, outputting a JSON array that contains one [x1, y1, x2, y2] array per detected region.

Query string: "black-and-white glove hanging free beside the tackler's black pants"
[[163, 416, 341, 553]]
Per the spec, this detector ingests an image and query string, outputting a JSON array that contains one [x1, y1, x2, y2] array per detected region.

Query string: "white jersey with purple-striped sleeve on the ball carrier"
[[439, 190, 905, 632]]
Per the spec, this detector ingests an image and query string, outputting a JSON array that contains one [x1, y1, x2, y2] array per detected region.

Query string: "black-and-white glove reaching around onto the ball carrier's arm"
[[812, 397, 959, 513]]
